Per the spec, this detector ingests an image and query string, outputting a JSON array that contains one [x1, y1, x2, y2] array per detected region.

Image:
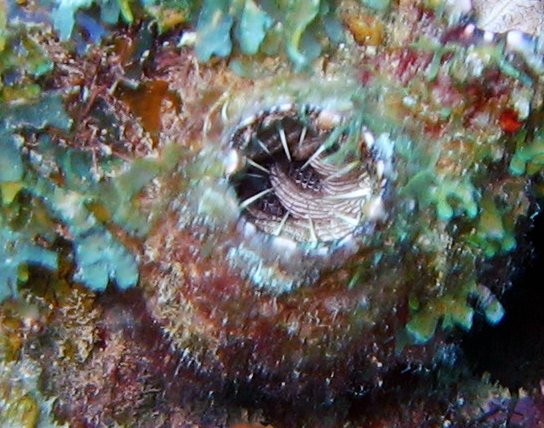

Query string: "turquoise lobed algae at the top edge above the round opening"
[[191, 0, 339, 69]]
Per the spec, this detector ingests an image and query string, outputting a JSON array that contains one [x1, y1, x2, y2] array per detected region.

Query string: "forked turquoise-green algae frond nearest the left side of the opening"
[[23, 142, 184, 291]]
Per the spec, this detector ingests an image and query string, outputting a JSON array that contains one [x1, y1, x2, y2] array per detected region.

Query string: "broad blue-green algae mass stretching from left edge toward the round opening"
[[0, 85, 187, 299]]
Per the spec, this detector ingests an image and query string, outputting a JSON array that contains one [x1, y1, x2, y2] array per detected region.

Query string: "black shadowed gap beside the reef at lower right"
[[462, 205, 544, 391]]
